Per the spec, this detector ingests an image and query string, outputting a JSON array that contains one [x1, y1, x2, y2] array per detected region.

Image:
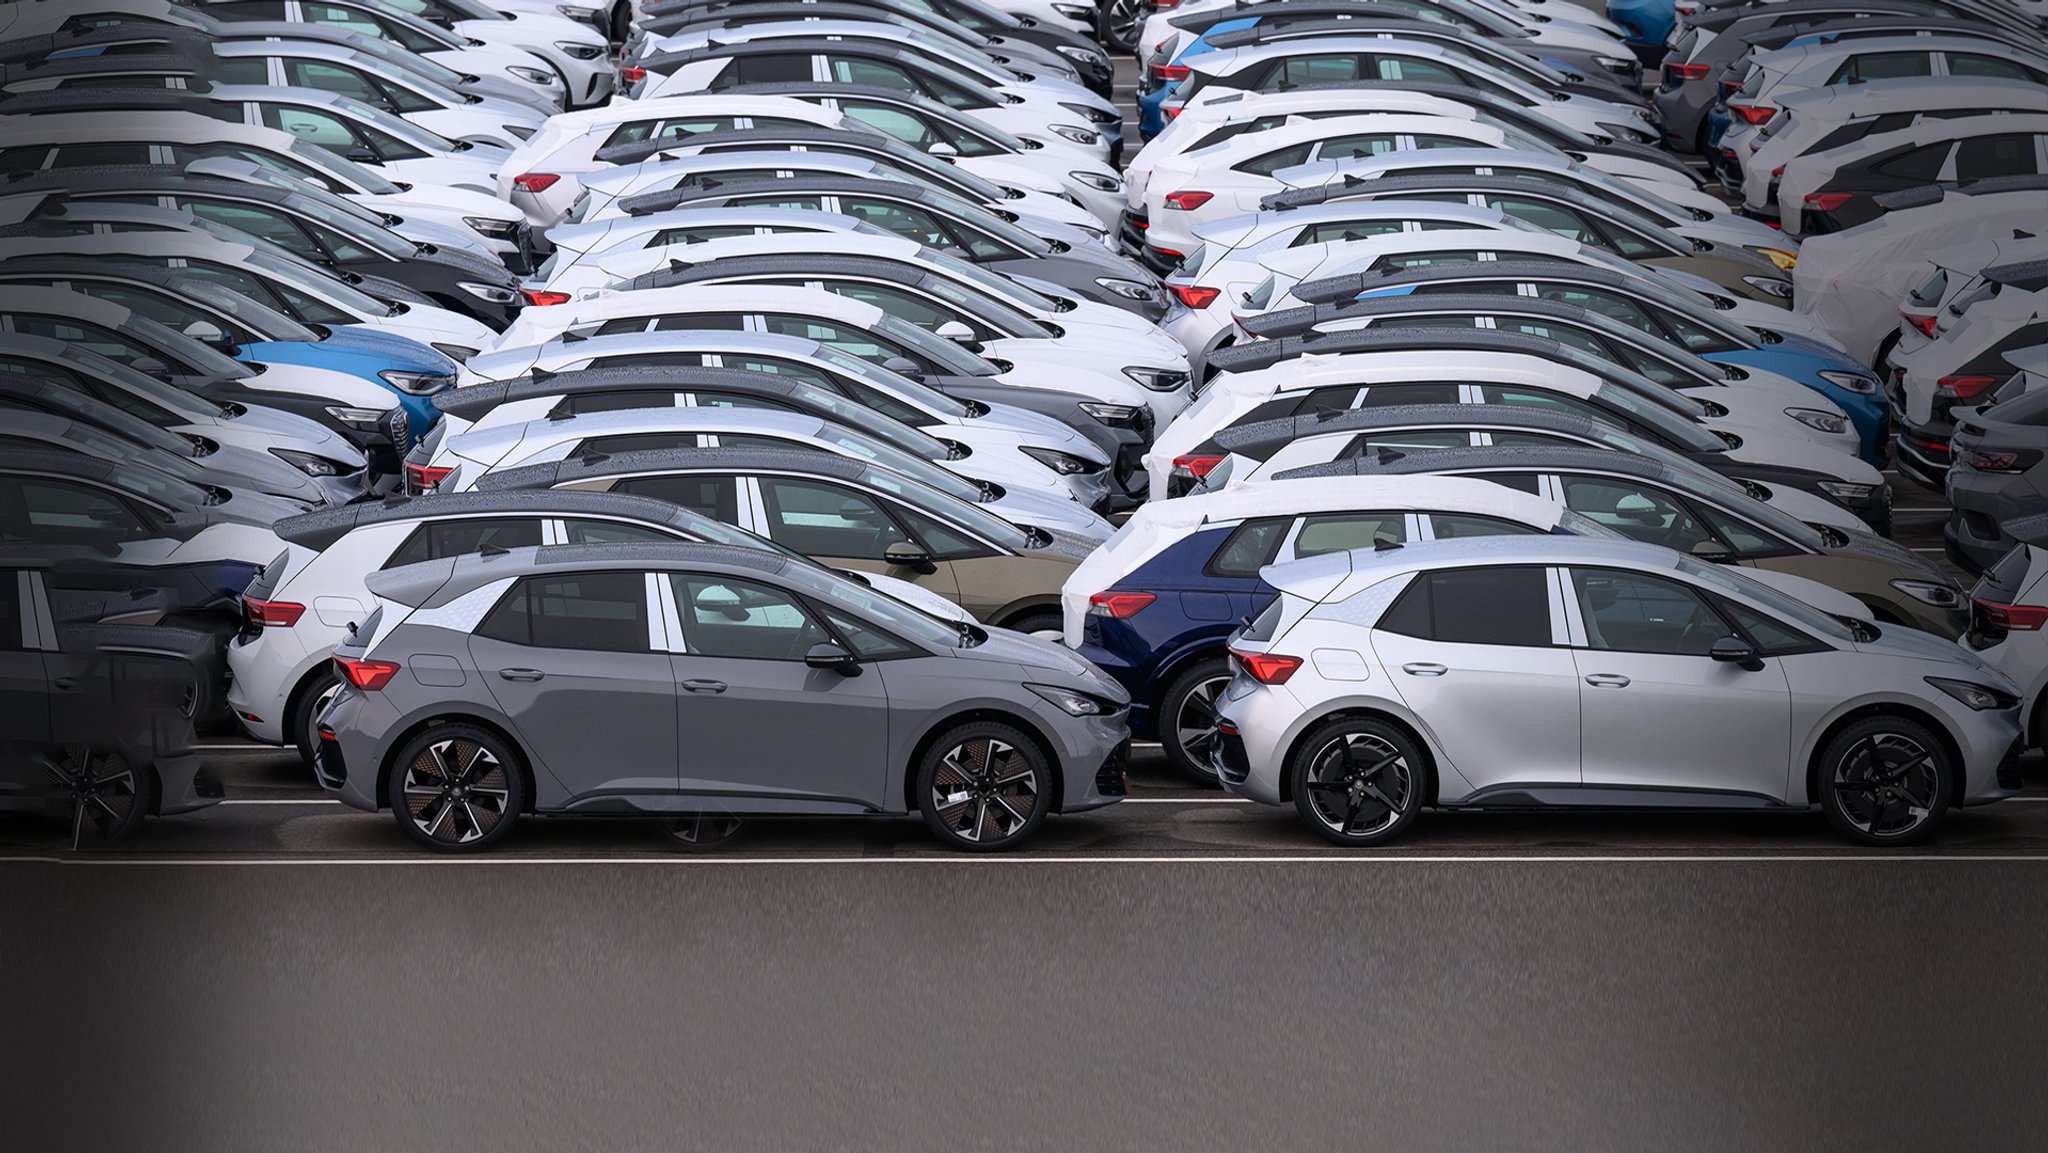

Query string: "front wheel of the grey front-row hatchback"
[[915, 721, 1053, 852]]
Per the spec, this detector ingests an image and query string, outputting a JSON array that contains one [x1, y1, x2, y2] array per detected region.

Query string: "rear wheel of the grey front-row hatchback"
[[385, 725, 526, 852]]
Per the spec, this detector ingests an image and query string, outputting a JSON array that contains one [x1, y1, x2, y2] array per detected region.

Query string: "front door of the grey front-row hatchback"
[[664, 573, 893, 813]]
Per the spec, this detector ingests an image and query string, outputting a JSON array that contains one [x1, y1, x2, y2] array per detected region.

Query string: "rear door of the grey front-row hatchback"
[[469, 571, 676, 805]]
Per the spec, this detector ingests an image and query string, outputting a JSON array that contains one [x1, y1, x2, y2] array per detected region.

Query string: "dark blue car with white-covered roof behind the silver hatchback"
[[1061, 477, 1608, 780]]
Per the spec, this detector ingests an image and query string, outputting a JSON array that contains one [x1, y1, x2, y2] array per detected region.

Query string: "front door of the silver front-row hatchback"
[[1567, 567, 1792, 801]]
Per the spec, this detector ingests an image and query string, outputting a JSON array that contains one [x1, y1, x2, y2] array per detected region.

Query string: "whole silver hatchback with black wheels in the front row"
[[1212, 537, 2019, 846]]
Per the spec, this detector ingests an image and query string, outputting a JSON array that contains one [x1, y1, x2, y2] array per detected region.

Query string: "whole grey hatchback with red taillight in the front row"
[[313, 543, 1130, 852]]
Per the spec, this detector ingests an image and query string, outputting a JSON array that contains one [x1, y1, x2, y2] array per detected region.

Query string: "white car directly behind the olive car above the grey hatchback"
[[428, 408, 1110, 543]]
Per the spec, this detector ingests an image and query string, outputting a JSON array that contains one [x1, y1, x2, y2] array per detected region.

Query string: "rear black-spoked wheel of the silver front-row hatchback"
[[1288, 717, 1430, 846]]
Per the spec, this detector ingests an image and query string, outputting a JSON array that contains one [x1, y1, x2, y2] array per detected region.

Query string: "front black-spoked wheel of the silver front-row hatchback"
[[1817, 717, 1956, 846]]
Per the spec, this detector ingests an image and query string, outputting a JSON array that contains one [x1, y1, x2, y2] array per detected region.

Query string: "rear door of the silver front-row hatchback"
[[1372, 565, 1579, 801]]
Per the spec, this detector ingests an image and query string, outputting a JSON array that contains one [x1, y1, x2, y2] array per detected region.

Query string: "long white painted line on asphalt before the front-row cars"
[[12, 850, 2048, 868]]
